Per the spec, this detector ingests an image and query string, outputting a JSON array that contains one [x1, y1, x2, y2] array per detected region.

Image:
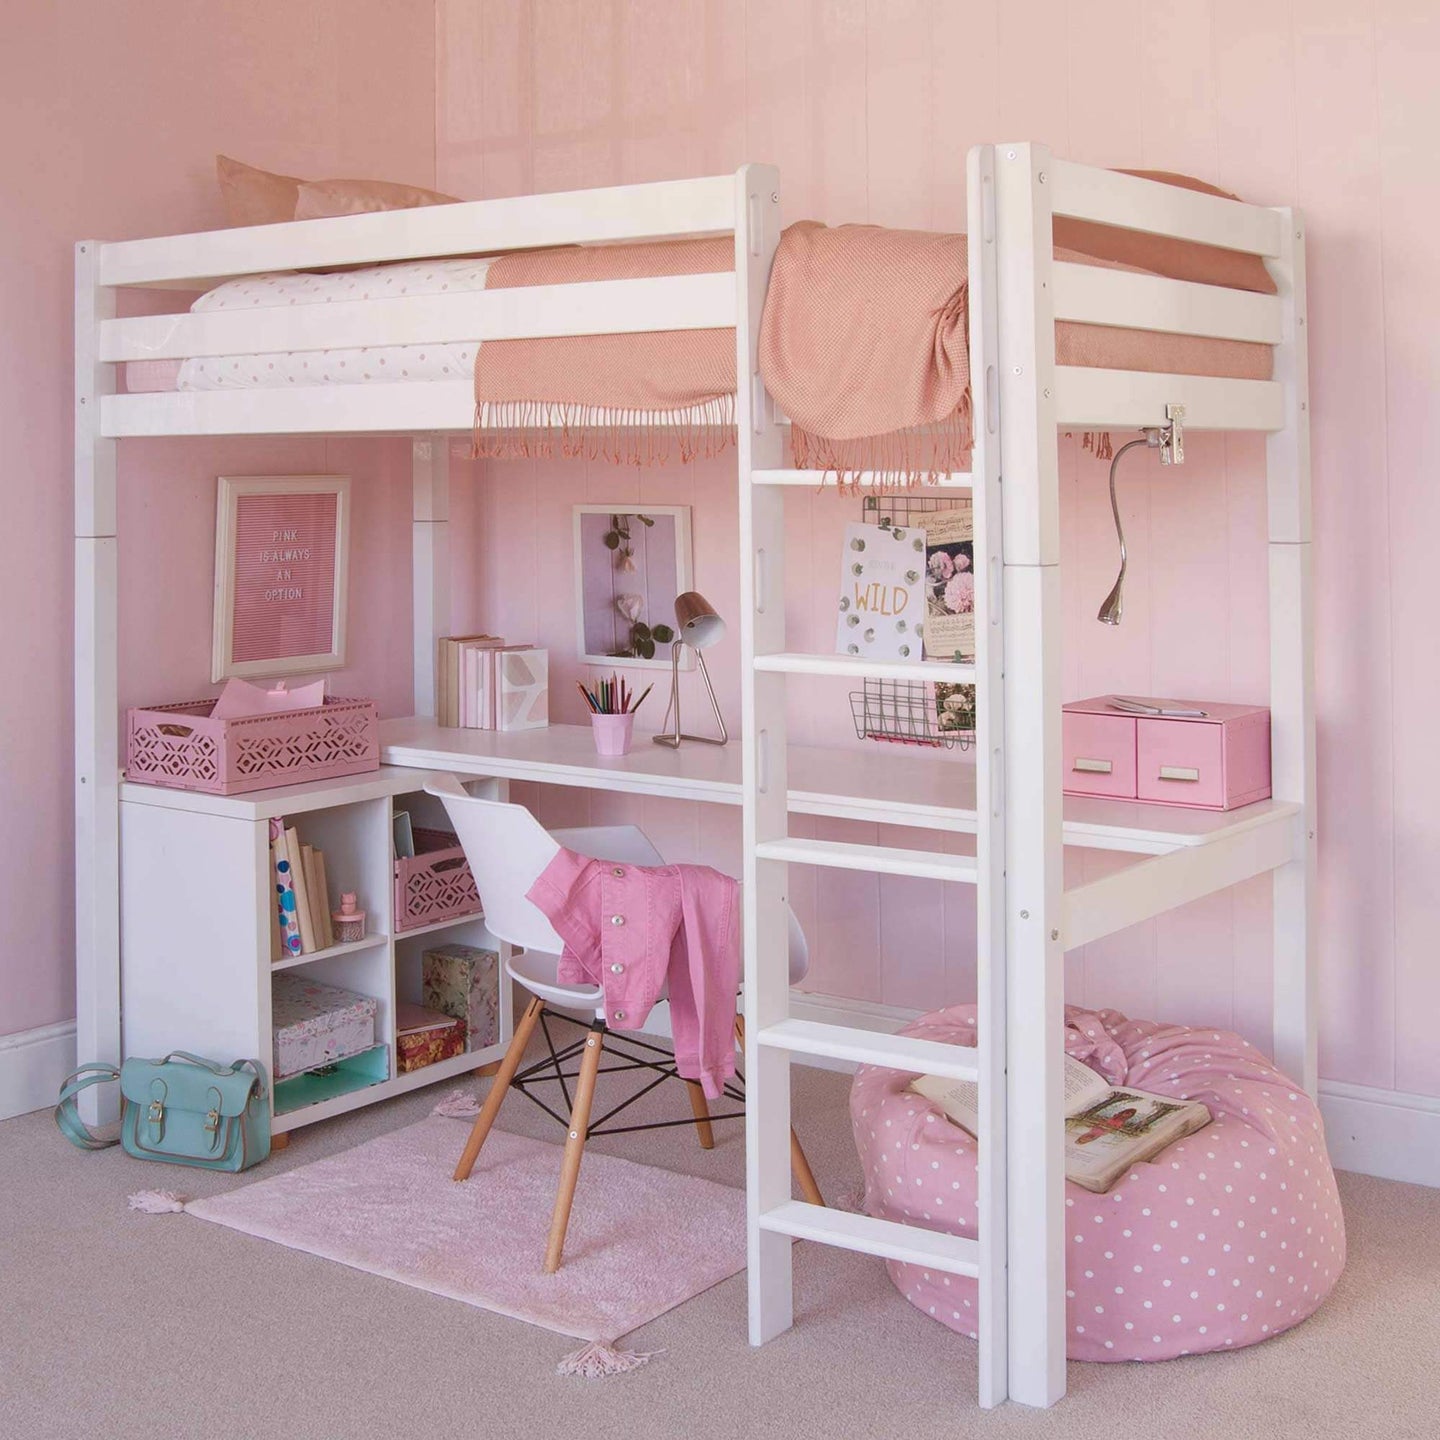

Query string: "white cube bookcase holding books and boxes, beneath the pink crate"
[[120, 766, 513, 1135]]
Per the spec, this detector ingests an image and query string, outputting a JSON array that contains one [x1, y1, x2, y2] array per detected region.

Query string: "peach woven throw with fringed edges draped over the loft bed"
[[475, 220, 1272, 484]]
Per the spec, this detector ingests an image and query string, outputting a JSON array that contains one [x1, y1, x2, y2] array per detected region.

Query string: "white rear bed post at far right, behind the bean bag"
[[1266, 209, 1319, 1096]]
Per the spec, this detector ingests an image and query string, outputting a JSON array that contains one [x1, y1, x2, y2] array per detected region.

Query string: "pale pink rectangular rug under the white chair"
[[186, 1116, 744, 1344]]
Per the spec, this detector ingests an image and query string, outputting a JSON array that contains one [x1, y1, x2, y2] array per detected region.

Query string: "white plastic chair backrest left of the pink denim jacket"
[[426, 785, 564, 955]]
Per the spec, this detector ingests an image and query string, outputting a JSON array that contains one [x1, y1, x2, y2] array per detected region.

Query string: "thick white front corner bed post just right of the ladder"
[[995, 144, 1066, 1405]]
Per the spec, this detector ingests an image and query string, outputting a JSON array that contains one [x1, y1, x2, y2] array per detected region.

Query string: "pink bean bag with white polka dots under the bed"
[[850, 1005, 1345, 1361]]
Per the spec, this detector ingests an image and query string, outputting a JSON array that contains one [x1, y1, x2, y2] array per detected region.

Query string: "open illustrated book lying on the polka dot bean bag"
[[910, 1056, 1210, 1195]]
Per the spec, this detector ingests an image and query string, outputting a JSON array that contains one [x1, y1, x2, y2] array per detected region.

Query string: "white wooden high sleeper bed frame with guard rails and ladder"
[[75, 144, 1316, 1405]]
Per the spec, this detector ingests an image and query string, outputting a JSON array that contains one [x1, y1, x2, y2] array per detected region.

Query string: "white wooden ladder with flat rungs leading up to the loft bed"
[[736, 147, 1008, 1407]]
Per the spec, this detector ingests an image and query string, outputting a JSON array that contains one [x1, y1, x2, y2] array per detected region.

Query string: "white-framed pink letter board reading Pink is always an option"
[[210, 475, 350, 681]]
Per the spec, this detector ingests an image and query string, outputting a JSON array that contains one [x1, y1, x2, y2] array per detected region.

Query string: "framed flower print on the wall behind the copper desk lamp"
[[575, 503, 694, 670]]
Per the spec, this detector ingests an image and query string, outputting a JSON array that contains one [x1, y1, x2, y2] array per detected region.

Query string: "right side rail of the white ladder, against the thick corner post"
[[966, 145, 1009, 1410]]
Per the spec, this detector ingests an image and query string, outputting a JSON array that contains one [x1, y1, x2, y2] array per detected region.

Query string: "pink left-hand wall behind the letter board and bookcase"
[[0, 0, 435, 1036]]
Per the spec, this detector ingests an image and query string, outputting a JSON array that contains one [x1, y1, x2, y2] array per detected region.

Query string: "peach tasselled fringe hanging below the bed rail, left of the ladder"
[[471, 395, 734, 467]]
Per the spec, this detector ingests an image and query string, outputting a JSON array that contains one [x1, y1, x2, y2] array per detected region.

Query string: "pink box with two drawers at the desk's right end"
[[1063, 696, 1270, 811]]
